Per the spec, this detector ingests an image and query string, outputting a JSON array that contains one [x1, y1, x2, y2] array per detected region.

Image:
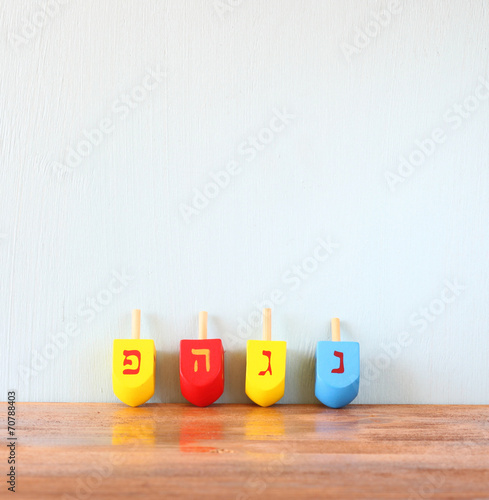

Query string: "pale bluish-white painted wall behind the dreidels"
[[0, 0, 489, 404]]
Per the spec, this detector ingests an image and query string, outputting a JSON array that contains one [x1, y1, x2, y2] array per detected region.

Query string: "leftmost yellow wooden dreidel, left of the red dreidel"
[[112, 309, 156, 406]]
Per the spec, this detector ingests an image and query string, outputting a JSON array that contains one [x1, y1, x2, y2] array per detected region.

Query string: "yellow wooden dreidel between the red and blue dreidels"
[[246, 309, 287, 406]]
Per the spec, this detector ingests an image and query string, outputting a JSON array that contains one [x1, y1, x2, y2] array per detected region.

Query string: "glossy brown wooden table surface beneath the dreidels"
[[6, 403, 489, 500]]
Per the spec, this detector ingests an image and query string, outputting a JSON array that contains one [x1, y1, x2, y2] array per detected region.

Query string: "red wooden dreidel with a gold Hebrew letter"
[[180, 311, 224, 406]]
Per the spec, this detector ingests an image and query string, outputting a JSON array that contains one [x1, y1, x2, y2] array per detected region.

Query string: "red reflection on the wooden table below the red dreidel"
[[179, 406, 222, 453]]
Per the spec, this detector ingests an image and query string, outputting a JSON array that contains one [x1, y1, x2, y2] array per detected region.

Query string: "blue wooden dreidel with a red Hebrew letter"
[[315, 318, 360, 408]]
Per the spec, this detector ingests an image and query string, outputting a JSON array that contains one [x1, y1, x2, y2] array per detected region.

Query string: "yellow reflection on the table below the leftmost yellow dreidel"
[[112, 407, 156, 445]]
